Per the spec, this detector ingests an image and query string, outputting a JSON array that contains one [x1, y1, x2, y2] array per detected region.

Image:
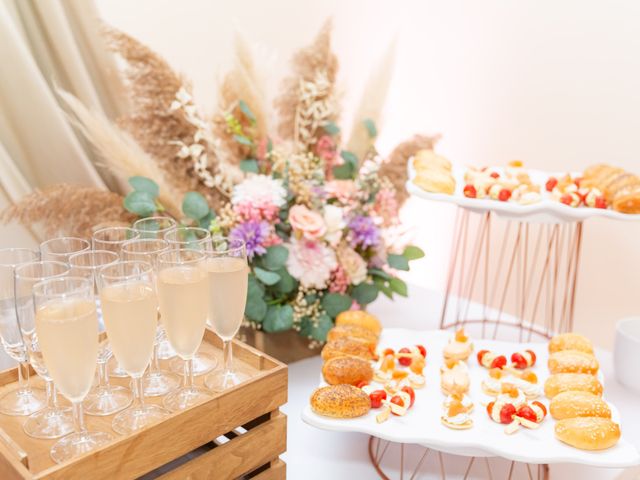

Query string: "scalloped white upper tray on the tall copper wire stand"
[[406, 159, 640, 223]]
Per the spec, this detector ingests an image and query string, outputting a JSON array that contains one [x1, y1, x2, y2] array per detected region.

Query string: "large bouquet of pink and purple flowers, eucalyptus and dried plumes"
[[5, 22, 435, 342]]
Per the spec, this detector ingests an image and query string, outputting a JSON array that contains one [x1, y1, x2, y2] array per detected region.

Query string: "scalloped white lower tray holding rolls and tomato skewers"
[[302, 328, 640, 468]]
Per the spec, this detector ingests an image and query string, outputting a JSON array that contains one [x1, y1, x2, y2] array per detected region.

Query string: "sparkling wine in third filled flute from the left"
[[158, 265, 209, 359]]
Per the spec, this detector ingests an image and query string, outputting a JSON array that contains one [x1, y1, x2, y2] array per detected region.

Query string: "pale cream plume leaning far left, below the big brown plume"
[[57, 89, 188, 218]]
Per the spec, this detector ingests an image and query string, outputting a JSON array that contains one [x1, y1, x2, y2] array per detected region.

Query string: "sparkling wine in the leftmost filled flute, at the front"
[[36, 299, 98, 402]]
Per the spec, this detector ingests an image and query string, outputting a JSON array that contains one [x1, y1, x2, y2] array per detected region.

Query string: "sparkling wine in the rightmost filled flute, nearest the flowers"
[[205, 257, 249, 340]]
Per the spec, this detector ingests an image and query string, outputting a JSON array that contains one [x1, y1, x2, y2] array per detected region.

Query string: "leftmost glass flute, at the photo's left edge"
[[0, 248, 46, 415]]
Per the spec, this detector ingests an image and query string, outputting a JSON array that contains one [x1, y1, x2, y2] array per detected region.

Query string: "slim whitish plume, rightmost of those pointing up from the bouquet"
[[347, 39, 396, 158]]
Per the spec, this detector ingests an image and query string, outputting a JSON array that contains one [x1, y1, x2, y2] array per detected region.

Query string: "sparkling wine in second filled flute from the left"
[[100, 282, 158, 377]]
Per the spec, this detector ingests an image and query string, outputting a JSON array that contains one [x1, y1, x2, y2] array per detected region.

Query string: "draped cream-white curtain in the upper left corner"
[[0, 0, 126, 247]]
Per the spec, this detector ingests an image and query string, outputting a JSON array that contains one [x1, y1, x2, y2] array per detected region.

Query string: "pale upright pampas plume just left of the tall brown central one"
[[214, 32, 269, 165]]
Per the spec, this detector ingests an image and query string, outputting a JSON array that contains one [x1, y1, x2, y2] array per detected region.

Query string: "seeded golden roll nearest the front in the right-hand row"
[[555, 417, 620, 450]]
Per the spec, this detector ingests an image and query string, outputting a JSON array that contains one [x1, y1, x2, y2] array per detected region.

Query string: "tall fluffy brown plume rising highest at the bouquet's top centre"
[[275, 20, 338, 150]]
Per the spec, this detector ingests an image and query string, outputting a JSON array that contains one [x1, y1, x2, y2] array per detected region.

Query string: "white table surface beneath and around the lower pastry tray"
[[283, 287, 640, 480]]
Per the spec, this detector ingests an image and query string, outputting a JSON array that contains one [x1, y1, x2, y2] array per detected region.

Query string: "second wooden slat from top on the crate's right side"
[[158, 413, 287, 480]]
